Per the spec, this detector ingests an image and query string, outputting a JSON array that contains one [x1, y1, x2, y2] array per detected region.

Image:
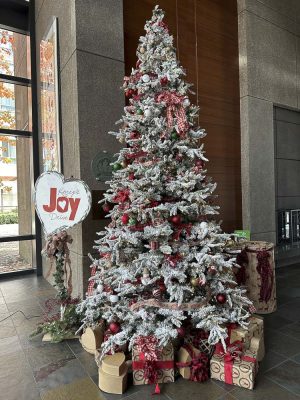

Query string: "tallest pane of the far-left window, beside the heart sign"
[[0, 135, 34, 241]]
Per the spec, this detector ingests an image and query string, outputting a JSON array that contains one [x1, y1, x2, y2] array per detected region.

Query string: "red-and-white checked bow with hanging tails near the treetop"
[[156, 91, 189, 135]]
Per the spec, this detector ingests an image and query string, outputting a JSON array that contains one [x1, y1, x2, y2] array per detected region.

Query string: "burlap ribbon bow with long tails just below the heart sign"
[[42, 231, 73, 295]]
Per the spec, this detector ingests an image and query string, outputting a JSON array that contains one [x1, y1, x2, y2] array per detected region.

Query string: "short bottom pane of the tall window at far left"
[[0, 240, 34, 274]]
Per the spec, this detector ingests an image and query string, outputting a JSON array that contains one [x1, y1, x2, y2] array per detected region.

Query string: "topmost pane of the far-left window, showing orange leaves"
[[0, 29, 31, 78]]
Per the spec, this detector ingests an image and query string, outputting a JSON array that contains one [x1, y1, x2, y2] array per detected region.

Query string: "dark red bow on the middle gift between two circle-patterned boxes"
[[176, 344, 209, 382]]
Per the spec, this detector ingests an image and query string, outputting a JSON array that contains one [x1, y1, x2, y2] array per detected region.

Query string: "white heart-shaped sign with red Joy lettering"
[[34, 171, 91, 235]]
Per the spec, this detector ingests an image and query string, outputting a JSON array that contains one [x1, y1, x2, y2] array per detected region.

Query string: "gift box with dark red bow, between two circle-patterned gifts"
[[176, 344, 209, 382]]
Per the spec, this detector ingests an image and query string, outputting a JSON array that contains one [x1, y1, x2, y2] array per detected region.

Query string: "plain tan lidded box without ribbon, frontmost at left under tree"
[[99, 353, 128, 394]]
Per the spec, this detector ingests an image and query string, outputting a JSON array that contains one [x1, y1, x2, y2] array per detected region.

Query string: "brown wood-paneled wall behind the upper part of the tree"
[[123, 0, 242, 232]]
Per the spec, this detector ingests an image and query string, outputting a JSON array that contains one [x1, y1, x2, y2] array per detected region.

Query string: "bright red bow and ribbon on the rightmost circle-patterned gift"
[[215, 340, 256, 385]]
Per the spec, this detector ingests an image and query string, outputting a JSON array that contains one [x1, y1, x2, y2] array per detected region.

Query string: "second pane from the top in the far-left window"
[[0, 82, 32, 131]]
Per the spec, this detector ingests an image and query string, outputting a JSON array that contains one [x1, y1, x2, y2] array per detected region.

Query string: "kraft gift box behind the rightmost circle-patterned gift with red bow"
[[230, 315, 265, 361]]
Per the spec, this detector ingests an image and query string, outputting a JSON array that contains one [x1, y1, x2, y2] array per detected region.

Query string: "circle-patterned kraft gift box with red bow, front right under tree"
[[210, 345, 258, 389]]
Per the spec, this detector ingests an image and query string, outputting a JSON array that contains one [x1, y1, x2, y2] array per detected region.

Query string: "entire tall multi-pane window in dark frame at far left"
[[0, 28, 36, 275]]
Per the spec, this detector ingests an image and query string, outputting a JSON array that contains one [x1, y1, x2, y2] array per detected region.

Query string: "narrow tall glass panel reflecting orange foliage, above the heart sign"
[[40, 19, 61, 171]]
